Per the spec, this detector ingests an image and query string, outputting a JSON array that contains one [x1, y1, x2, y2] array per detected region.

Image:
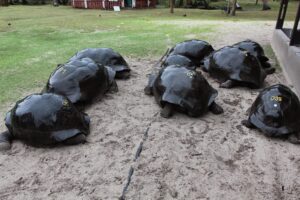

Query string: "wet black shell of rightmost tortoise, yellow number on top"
[[248, 84, 300, 136]]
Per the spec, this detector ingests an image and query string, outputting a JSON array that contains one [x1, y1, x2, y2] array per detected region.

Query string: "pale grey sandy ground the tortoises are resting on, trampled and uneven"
[[0, 22, 300, 200]]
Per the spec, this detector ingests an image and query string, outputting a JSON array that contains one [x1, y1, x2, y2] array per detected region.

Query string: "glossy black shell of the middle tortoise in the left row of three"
[[46, 58, 115, 103]]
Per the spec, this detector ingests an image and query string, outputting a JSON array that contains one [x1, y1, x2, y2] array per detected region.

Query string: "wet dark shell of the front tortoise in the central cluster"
[[153, 65, 218, 117]]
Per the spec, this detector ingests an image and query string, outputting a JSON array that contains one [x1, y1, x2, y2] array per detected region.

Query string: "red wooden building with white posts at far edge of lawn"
[[72, 0, 157, 10]]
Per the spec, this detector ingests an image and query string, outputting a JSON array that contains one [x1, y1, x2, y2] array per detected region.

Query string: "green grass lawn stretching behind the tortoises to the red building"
[[0, 1, 297, 110]]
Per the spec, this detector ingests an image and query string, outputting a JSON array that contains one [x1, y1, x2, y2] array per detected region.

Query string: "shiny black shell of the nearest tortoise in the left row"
[[5, 93, 90, 145]]
